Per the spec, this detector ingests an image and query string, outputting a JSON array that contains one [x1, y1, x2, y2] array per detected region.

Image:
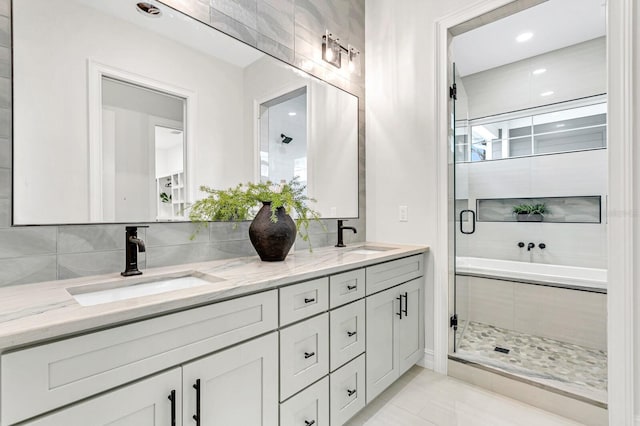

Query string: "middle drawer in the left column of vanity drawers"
[[280, 313, 329, 401]]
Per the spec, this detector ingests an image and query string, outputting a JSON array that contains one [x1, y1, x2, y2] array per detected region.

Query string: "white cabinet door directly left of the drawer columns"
[[182, 333, 278, 426]]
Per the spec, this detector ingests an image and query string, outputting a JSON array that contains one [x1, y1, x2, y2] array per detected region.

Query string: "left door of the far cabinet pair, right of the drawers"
[[366, 288, 400, 404]]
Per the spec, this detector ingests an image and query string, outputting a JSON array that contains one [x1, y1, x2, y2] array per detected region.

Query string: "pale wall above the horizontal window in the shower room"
[[462, 37, 607, 118]]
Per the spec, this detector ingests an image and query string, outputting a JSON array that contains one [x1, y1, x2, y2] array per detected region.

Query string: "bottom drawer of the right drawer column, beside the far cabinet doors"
[[329, 354, 366, 426]]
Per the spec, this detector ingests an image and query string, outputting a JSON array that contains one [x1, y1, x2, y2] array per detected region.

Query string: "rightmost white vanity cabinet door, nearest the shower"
[[398, 278, 424, 374]]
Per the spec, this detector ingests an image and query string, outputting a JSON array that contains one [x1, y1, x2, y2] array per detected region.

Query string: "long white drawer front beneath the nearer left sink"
[[0, 290, 278, 425]]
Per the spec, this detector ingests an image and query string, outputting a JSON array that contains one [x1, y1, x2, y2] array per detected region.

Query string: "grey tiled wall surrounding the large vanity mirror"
[[0, 0, 365, 286]]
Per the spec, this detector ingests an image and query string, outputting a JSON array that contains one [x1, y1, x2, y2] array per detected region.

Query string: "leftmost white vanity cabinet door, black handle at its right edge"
[[25, 367, 182, 426]]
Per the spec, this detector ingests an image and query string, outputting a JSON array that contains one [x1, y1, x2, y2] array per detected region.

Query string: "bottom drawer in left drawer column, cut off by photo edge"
[[280, 377, 329, 426]]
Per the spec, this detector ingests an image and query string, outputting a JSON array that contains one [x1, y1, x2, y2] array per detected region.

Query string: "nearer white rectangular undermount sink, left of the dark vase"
[[67, 272, 224, 306]]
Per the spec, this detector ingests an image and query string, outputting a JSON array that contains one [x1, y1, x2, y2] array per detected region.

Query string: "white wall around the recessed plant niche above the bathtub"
[[456, 149, 607, 268]]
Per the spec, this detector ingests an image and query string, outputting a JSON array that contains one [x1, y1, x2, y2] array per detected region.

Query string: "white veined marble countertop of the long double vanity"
[[0, 242, 428, 352]]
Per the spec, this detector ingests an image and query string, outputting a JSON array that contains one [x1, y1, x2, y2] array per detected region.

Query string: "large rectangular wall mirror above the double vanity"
[[12, 0, 358, 225]]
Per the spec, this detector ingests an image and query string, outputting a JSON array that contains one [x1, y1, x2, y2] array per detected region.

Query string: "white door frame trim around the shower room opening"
[[433, 0, 640, 426]]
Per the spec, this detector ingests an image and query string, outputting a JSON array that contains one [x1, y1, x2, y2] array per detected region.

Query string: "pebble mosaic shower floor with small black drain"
[[449, 321, 607, 408]]
